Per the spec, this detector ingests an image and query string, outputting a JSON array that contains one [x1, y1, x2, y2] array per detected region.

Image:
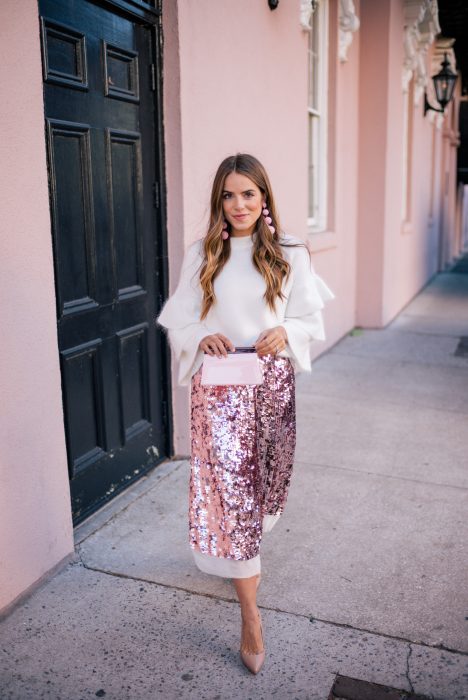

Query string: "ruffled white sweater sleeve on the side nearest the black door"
[[156, 241, 210, 386]]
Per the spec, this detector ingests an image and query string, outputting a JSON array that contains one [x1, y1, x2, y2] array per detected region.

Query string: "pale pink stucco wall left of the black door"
[[0, 0, 73, 610]]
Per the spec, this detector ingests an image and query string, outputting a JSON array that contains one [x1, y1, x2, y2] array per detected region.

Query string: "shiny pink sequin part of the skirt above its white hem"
[[189, 355, 296, 560]]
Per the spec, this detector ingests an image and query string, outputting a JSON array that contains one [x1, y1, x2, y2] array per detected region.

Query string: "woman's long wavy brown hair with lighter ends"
[[200, 153, 310, 321]]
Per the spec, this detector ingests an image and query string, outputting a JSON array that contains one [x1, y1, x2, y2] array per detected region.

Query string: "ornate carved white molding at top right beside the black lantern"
[[402, 0, 440, 107]]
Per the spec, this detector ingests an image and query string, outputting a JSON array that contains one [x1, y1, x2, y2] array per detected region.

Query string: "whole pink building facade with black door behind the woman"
[[0, 0, 467, 610]]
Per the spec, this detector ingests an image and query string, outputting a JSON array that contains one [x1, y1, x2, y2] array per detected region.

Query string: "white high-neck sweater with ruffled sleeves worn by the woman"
[[157, 234, 334, 385]]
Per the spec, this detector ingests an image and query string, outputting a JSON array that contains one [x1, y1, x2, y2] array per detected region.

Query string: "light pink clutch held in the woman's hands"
[[201, 352, 263, 386]]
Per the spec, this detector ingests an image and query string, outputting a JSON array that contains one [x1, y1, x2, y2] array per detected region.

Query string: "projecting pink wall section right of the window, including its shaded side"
[[356, 0, 455, 328]]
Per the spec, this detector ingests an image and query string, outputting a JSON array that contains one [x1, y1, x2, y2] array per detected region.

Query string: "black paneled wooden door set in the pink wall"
[[39, 0, 169, 523]]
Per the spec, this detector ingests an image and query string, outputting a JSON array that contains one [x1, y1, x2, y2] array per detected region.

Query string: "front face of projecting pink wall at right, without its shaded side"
[[380, 2, 438, 325]]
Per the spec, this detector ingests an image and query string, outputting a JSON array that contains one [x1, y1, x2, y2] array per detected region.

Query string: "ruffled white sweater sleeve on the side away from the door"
[[281, 248, 335, 372]]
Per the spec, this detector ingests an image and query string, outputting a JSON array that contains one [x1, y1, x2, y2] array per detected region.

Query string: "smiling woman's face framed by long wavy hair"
[[222, 173, 263, 236]]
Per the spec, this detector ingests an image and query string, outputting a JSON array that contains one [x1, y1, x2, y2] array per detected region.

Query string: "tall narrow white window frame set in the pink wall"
[[307, 0, 329, 233]]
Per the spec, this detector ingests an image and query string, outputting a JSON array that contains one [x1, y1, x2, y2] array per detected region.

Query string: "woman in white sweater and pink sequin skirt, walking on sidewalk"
[[158, 154, 333, 673]]
